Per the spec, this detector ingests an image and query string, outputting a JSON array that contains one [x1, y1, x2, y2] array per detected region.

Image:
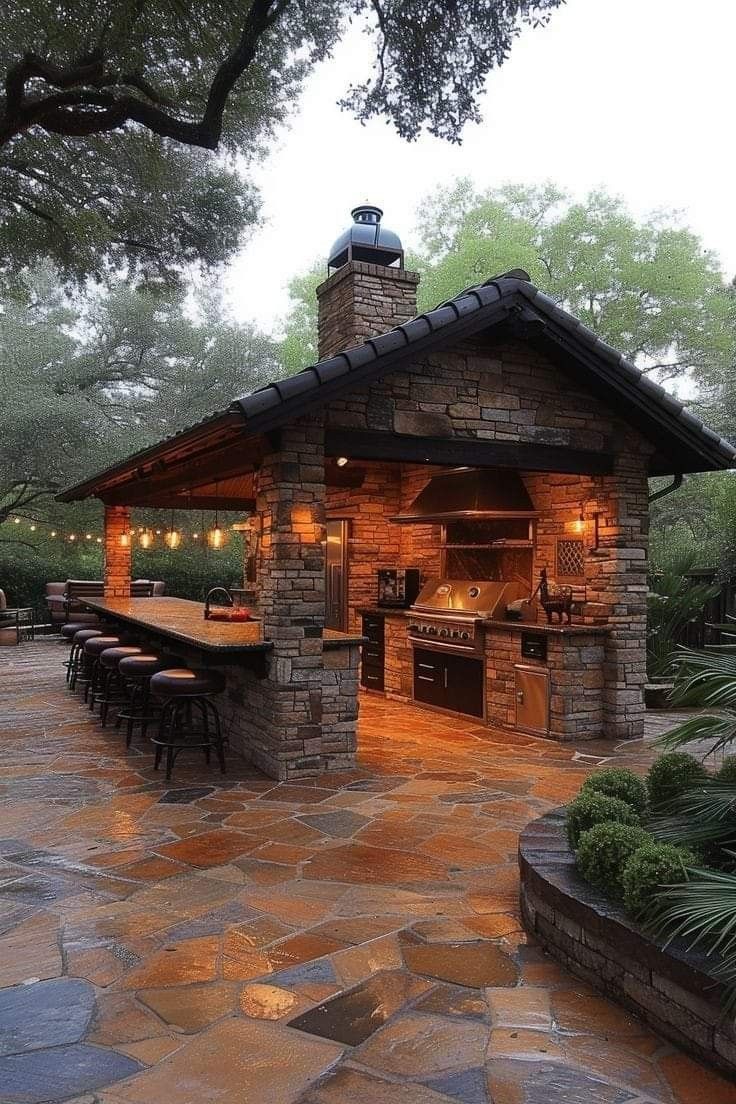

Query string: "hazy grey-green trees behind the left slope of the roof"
[[0, 268, 278, 539]]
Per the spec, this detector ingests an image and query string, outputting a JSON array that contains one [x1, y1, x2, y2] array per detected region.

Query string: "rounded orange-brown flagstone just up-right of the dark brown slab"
[[403, 941, 519, 989]]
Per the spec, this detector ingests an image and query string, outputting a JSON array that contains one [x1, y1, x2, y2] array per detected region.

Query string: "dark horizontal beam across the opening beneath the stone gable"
[[324, 427, 614, 476]]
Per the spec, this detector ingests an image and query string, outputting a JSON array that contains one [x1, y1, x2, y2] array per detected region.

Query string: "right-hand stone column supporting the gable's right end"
[[586, 439, 649, 740]]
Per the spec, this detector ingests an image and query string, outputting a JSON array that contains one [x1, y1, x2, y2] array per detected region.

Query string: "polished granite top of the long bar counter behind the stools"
[[84, 597, 274, 654]]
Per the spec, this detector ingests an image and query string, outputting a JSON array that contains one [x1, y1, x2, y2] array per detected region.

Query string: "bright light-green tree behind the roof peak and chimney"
[[280, 180, 736, 388]]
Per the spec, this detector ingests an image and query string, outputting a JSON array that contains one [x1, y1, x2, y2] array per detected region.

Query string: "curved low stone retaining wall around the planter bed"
[[519, 809, 736, 1079]]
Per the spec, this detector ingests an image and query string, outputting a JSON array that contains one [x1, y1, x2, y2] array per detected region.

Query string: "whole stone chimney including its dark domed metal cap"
[[317, 204, 419, 360]]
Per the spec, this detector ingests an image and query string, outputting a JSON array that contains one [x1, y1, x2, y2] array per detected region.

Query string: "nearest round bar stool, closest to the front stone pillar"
[[151, 667, 227, 782]]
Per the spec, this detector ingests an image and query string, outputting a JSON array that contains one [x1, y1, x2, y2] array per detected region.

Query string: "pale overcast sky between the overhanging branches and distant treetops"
[[222, 0, 736, 328]]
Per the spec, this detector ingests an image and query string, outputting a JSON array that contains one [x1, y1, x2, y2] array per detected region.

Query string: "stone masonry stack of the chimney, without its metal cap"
[[317, 261, 419, 360]]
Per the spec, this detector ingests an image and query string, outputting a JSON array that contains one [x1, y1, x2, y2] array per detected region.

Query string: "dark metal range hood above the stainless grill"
[[390, 468, 536, 524]]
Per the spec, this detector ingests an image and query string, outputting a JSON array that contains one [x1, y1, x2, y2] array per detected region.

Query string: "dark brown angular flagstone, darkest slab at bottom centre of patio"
[[289, 972, 429, 1047]]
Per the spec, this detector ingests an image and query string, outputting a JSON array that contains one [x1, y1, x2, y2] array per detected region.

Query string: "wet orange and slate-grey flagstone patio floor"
[[0, 640, 736, 1104]]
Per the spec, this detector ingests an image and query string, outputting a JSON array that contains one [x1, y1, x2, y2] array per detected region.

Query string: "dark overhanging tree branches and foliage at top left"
[[0, 0, 564, 278]]
